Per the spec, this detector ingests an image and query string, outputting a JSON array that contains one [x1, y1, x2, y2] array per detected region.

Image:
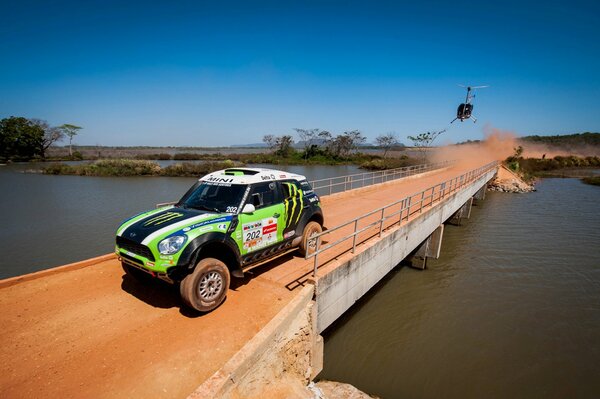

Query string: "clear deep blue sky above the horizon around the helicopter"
[[0, 0, 600, 146]]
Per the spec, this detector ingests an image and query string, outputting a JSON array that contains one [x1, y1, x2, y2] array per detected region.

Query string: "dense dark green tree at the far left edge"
[[0, 116, 44, 160]]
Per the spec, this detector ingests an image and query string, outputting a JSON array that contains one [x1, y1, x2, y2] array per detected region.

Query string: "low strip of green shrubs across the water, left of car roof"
[[42, 159, 236, 177]]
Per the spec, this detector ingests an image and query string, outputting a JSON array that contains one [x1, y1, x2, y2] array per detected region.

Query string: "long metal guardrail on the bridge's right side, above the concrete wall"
[[304, 161, 498, 278]]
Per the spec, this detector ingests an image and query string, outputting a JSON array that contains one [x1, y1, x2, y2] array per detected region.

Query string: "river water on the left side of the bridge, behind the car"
[[0, 163, 364, 278]]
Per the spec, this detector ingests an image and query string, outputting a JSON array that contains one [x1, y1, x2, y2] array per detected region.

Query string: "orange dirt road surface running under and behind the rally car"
[[0, 162, 488, 398]]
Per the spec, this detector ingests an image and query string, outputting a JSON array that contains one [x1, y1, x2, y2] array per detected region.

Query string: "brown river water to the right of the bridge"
[[319, 179, 600, 398]]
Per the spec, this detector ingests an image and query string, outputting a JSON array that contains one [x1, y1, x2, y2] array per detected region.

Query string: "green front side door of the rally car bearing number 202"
[[236, 181, 285, 255]]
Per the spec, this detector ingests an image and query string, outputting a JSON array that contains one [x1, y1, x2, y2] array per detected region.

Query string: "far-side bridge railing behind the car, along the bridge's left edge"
[[310, 161, 453, 195]]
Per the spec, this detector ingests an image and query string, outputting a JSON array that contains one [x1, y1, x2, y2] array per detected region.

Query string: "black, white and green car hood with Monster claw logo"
[[117, 207, 225, 245]]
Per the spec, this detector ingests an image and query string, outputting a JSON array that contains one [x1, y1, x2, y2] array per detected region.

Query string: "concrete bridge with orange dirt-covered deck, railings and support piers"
[[0, 162, 498, 398]]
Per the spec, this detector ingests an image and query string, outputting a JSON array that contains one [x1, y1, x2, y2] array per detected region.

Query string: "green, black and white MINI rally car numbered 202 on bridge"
[[115, 168, 323, 312]]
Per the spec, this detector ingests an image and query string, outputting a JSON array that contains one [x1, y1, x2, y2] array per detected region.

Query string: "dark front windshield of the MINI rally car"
[[177, 182, 247, 213]]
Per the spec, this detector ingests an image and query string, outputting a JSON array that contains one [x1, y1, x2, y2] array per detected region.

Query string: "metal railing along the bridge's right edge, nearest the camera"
[[305, 161, 498, 278]]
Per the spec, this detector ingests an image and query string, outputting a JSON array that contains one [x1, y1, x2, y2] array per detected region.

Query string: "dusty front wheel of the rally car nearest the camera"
[[179, 258, 230, 312]]
